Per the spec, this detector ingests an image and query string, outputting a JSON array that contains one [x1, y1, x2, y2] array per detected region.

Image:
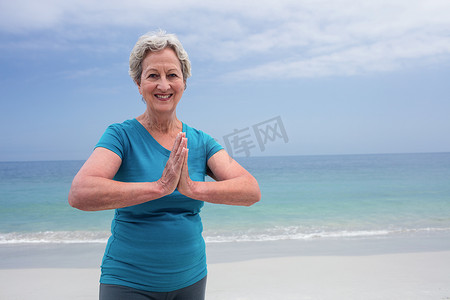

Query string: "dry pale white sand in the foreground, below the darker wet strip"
[[0, 251, 450, 300]]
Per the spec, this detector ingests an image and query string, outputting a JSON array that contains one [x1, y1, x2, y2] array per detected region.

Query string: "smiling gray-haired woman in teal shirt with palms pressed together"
[[69, 31, 261, 300]]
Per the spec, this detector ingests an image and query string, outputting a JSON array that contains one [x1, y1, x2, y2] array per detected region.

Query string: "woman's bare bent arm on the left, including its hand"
[[69, 134, 187, 211]]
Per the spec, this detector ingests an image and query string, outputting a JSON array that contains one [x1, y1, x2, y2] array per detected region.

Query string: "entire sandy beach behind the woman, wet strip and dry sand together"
[[0, 237, 450, 300]]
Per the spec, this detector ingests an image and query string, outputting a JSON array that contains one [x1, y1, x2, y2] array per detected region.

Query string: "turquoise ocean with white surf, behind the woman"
[[0, 153, 450, 244]]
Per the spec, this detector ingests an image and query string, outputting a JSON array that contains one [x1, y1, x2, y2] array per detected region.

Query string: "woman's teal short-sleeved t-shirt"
[[96, 119, 223, 292]]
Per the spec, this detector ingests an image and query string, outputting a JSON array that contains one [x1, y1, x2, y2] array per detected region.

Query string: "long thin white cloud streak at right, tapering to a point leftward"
[[226, 36, 450, 80]]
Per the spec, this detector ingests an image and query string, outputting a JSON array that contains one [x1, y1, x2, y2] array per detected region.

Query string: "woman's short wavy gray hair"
[[128, 30, 191, 84]]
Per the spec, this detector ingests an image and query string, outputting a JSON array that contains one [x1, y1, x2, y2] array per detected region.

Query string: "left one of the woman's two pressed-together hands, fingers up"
[[157, 132, 187, 195]]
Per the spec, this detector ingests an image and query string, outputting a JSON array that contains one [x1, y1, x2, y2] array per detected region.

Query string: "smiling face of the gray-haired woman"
[[138, 48, 185, 113]]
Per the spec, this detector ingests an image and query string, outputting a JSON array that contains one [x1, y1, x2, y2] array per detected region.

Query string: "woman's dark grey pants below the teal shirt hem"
[[99, 276, 206, 300]]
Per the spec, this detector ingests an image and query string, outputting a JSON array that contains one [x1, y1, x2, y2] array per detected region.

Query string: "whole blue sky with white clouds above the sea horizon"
[[0, 0, 450, 161]]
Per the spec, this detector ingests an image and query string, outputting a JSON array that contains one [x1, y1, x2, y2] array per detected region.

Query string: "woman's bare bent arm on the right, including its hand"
[[178, 150, 261, 206]]
